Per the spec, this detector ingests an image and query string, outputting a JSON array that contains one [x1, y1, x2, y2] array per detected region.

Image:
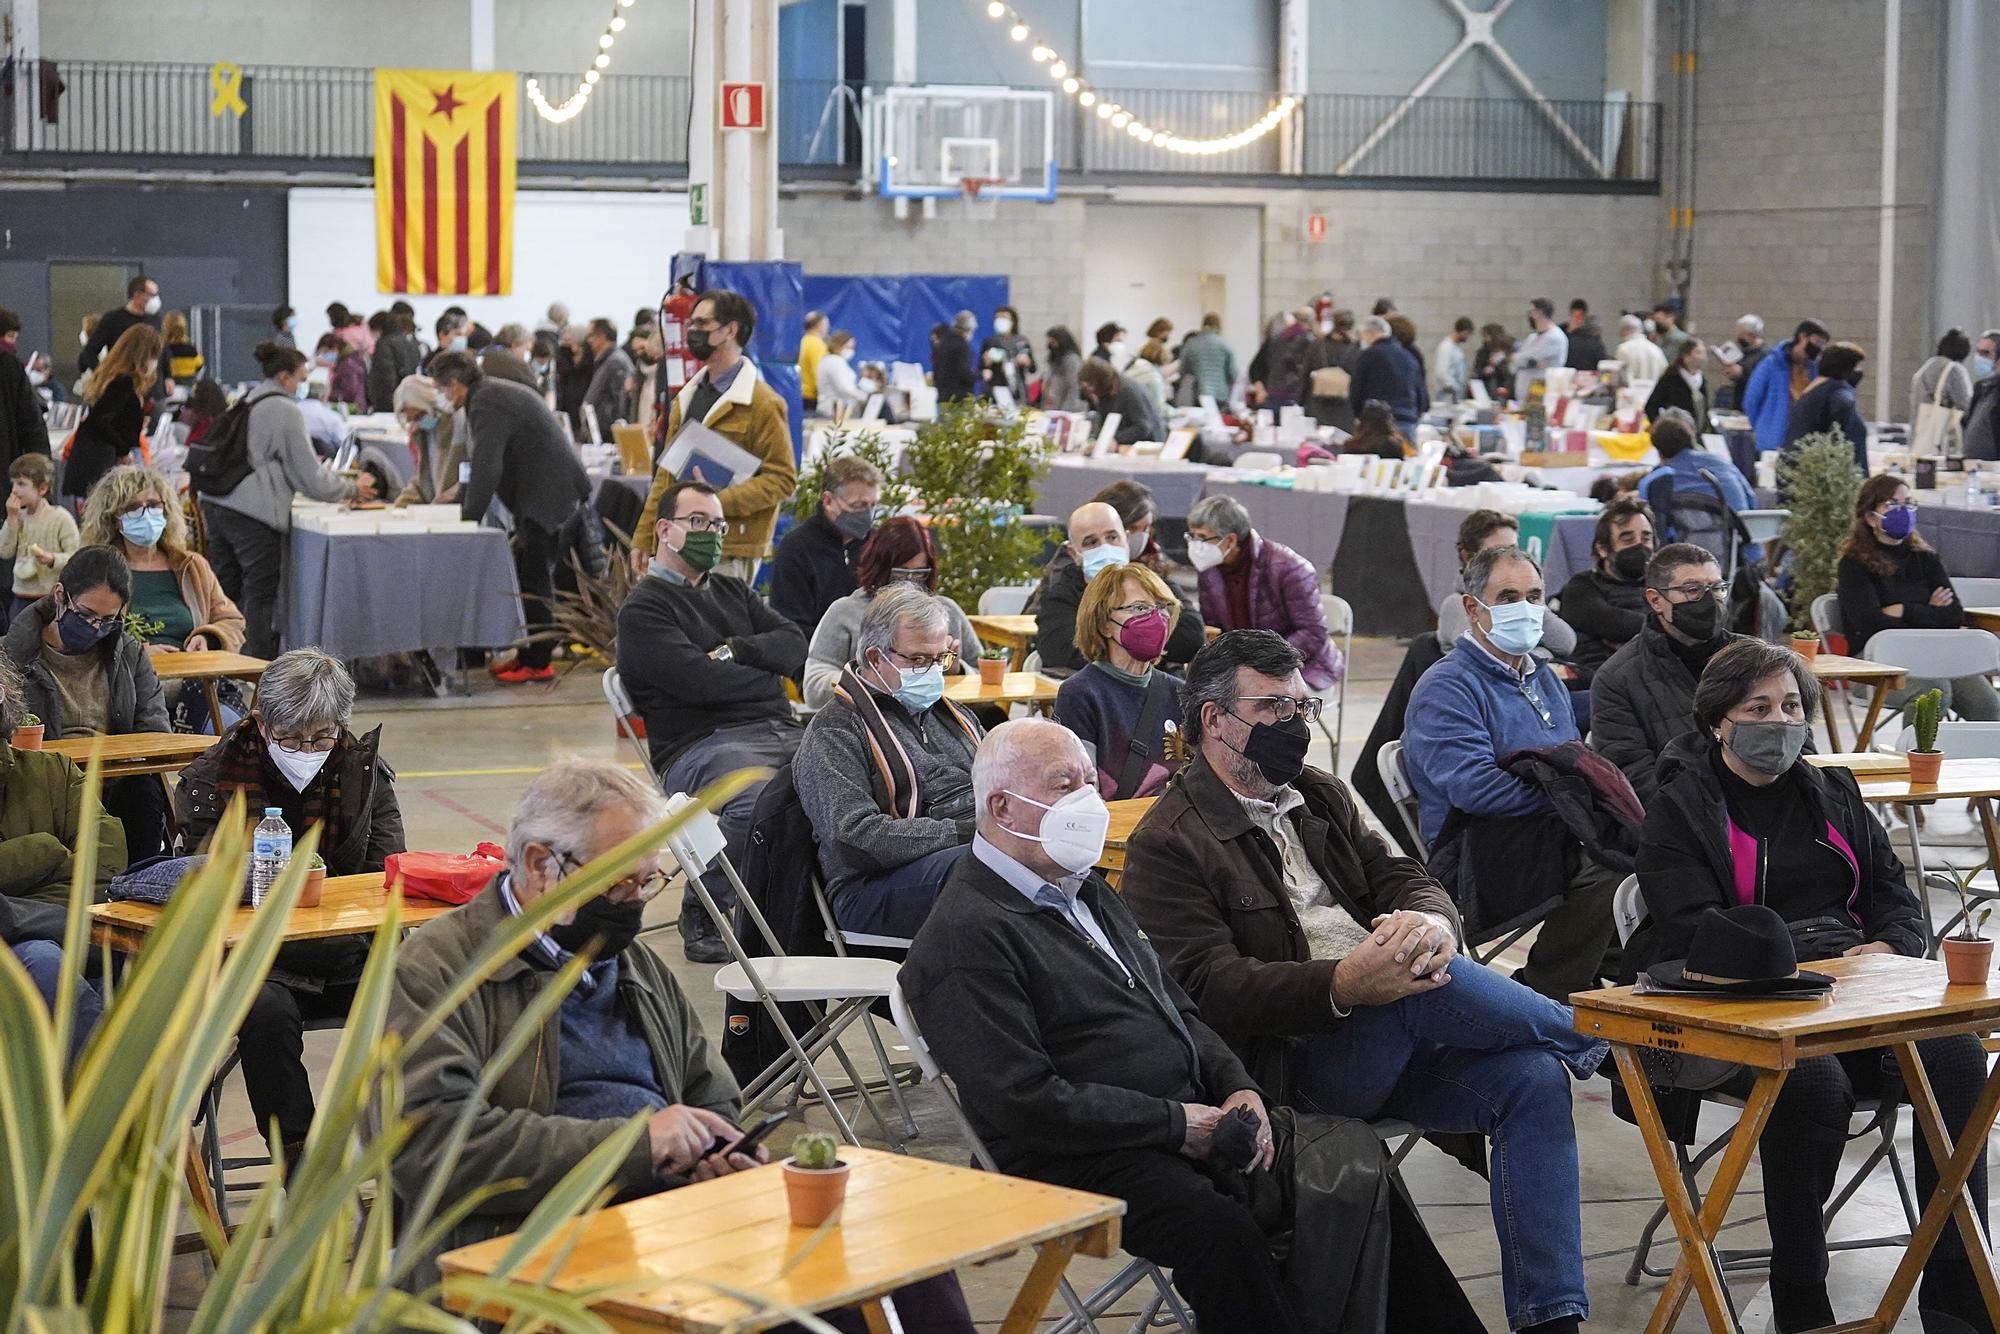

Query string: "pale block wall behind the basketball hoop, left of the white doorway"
[[778, 194, 1088, 342]]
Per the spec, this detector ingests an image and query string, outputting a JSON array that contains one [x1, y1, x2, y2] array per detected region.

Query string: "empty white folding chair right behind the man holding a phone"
[[666, 792, 916, 1152]]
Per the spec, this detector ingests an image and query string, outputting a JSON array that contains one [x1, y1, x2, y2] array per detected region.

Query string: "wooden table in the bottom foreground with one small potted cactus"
[[438, 1146, 1126, 1334]]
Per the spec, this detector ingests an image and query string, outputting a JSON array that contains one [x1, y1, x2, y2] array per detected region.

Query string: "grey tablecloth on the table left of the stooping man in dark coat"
[[284, 528, 524, 660]]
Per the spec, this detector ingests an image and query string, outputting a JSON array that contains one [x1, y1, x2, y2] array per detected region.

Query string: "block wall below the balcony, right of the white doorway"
[[1264, 190, 1660, 360]]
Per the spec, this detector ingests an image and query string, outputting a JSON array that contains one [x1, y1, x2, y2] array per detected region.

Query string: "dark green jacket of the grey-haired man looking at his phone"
[[388, 882, 740, 1268]]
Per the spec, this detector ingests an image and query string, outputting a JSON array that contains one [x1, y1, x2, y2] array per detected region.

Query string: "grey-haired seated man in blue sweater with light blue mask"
[[1402, 546, 1620, 1000]]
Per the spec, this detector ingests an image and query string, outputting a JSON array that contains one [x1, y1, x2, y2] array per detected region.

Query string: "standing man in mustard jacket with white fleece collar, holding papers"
[[632, 292, 798, 584]]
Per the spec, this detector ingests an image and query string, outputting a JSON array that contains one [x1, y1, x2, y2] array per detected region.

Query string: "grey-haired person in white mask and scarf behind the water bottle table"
[[174, 648, 404, 1162]]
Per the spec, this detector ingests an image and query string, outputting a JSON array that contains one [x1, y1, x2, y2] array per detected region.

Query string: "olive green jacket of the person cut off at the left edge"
[[0, 746, 126, 902]]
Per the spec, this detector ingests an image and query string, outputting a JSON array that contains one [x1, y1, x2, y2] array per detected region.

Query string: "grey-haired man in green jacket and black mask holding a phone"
[[388, 760, 972, 1334]]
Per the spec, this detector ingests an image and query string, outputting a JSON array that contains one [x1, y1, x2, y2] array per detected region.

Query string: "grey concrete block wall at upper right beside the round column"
[[1690, 0, 1940, 420]]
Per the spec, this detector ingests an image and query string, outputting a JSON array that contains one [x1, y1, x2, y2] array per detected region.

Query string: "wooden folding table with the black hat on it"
[[1570, 954, 2000, 1334]]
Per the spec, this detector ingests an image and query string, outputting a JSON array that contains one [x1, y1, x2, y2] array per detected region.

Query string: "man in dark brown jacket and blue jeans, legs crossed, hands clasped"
[[1122, 630, 1606, 1334]]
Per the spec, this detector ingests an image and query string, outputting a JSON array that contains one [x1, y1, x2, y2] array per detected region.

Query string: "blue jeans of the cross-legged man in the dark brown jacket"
[[1298, 958, 1610, 1330]]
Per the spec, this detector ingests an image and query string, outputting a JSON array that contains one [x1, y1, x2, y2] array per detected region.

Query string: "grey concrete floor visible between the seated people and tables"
[[168, 640, 1984, 1332]]
